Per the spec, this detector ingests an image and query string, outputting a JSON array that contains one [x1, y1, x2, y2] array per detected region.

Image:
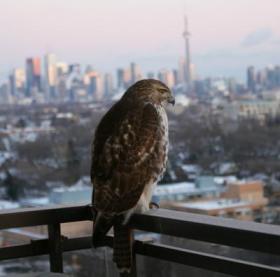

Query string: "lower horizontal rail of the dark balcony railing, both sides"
[[0, 234, 280, 277]]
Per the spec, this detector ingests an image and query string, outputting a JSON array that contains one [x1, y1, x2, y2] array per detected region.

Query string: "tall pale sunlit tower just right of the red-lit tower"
[[45, 54, 57, 99]]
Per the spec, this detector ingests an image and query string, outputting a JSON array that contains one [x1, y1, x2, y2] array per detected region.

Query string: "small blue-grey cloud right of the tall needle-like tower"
[[241, 28, 273, 47]]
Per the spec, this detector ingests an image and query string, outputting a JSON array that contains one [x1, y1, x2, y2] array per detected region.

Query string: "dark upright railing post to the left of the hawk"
[[48, 223, 63, 273]]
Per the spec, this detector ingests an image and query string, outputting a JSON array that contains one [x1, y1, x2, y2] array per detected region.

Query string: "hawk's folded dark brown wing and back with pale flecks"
[[91, 102, 160, 213]]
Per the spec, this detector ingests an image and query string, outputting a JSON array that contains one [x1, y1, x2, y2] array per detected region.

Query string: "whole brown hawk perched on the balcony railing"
[[91, 79, 175, 272]]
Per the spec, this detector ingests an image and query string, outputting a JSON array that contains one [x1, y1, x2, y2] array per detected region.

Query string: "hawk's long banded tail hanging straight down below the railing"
[[113, 222, 133, 273]]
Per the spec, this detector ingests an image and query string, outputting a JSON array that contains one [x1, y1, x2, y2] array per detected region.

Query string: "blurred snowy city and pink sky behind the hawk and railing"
[[0, 0, 280, 276]]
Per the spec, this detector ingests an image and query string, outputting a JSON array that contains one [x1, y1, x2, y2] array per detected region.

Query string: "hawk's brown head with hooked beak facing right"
[[124, 79, 175, 105]]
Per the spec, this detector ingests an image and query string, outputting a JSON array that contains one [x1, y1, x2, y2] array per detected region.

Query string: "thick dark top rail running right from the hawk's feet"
[[131, 209, 280, 255]]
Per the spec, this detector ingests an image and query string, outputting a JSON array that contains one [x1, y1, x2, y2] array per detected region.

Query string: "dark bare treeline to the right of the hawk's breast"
[[171, 106, 280, 174]]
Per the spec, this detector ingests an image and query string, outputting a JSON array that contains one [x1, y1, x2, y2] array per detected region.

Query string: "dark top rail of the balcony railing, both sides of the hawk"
[[0, 205, 280, 255]]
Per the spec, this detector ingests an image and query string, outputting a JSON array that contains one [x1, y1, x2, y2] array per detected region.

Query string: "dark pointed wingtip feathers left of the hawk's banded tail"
[[92, 212, 114, 248]]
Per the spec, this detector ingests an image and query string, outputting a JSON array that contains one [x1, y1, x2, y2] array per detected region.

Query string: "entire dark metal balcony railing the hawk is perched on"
[[0, 205, 280, 277]]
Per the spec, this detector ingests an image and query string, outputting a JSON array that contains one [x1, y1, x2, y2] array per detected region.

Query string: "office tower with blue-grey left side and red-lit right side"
[[26, 58, 41, 96]]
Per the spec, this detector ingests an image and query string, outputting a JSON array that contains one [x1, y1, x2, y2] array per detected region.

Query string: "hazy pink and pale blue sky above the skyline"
[[0, 0, 280, 79]]
